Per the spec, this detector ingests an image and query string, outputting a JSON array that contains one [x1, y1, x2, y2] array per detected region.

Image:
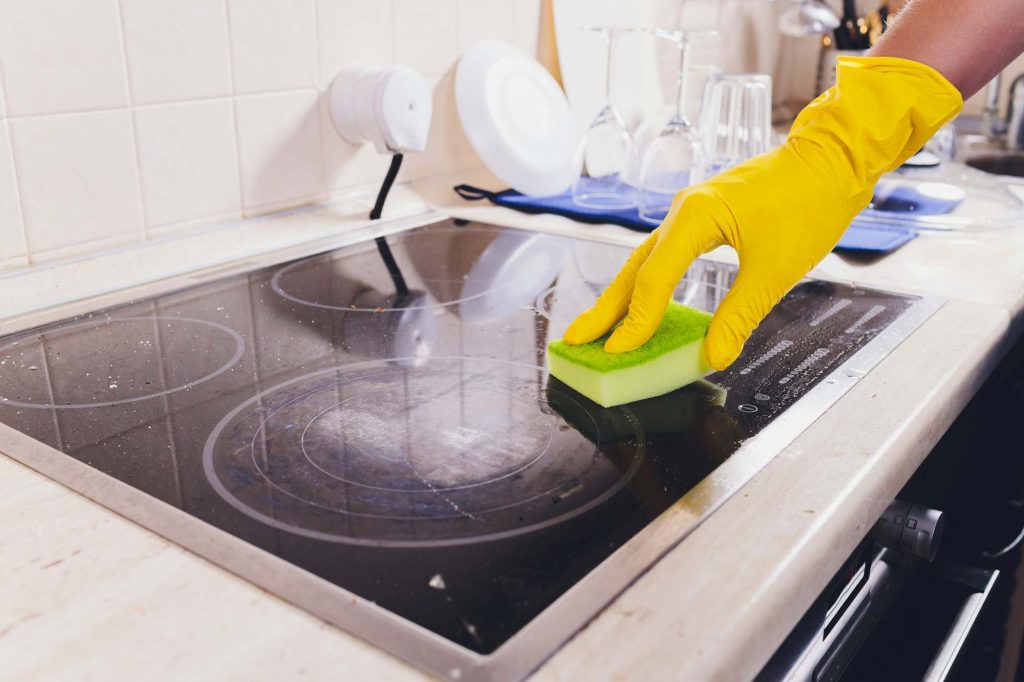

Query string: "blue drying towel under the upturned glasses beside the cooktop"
[[454, 184, 918, 254]]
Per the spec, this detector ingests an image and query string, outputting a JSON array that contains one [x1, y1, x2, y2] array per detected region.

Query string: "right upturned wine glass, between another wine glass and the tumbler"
[[638, 29, 718, 224]]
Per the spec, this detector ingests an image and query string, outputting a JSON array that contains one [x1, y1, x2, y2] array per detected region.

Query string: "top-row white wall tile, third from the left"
[[227, 0, 317, 92]]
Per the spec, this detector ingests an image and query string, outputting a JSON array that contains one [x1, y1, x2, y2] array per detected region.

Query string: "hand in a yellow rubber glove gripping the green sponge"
[[564, 57, 963, 370]]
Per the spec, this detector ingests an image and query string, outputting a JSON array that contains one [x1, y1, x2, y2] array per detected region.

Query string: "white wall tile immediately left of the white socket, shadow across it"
[[236, 90, 324, 213]]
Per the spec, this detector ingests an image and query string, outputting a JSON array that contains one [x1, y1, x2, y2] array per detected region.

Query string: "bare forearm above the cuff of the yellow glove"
[[870, 0, 1024, 99]]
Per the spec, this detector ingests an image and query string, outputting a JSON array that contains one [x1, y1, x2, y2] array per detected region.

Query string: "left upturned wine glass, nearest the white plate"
[[572, 27, 642, 210]]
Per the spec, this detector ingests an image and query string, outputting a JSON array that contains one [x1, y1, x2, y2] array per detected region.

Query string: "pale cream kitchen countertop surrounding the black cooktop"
[[0, 174, 1024, 680]]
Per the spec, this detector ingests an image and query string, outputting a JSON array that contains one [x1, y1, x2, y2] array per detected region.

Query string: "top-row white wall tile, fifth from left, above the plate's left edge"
[[394, 0, 457, 77]]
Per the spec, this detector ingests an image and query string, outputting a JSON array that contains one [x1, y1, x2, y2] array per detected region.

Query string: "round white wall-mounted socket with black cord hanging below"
[[331, 67, 432, 154]]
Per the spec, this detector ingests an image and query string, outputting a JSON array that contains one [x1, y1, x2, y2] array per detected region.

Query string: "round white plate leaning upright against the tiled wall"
[[455, 40, 579, 197]]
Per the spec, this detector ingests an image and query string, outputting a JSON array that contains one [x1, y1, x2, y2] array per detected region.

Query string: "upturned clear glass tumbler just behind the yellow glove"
[[697, 74, 772, 179]]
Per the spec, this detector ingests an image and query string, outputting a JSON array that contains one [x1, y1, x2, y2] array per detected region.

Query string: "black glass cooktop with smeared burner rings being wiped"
[[0, 221, 911, 653]]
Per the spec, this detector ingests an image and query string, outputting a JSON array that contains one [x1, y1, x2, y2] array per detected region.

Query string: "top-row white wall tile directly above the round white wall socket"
[[316, 0, 394, 86]]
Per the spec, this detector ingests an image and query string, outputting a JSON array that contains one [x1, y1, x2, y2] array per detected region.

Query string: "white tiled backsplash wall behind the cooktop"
[[0, 0, 541, 267]]
